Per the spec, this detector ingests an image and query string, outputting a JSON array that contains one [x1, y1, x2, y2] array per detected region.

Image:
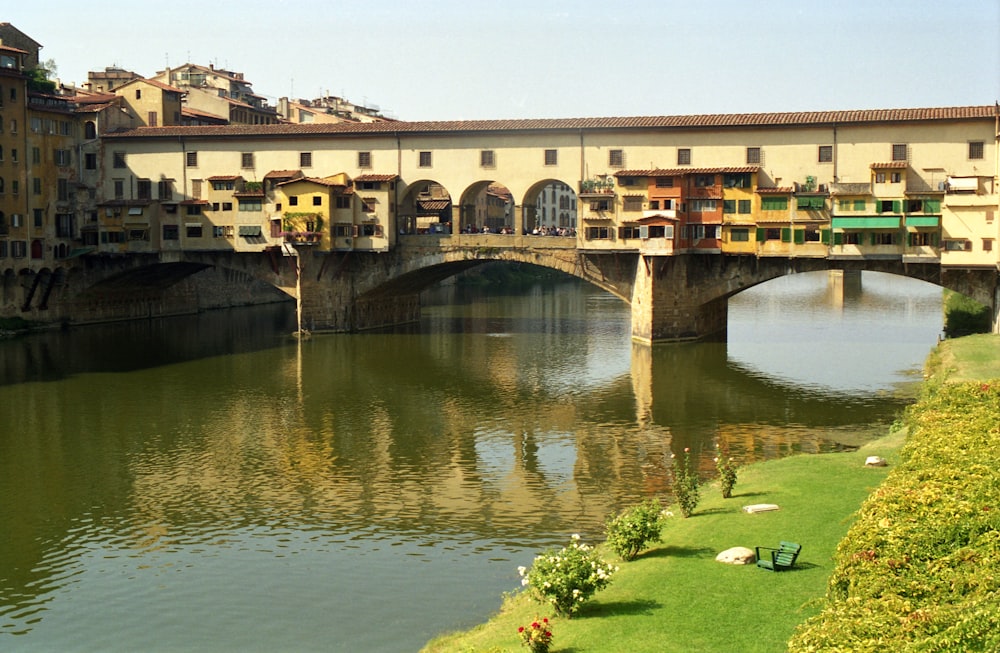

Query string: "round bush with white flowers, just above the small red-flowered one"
[[517, 535, 618, 617]]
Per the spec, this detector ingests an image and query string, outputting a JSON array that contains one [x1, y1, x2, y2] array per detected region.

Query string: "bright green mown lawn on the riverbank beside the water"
[[424, 336, 1000, 653]]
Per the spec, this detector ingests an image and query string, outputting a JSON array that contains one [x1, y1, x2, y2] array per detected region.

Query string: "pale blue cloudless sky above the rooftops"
[[0, 0, 1000, 120]]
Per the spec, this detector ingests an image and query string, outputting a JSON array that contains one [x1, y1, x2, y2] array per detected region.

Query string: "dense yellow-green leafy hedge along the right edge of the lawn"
[[789, 380, 1000, 652]]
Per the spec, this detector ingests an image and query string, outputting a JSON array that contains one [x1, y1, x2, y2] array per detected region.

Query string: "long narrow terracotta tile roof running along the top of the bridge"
[[103, 104, 998, 138]]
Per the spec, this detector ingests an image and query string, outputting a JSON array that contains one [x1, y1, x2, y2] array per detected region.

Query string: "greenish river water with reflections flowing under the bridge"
[[0, 273, 941, 652]]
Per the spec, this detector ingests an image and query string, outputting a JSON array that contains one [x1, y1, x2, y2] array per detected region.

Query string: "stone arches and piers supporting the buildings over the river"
[[11, 234, 1000, 343]]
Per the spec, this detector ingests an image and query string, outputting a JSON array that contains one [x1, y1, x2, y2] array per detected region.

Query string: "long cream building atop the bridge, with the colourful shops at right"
[[92, 106, 998, 267]]
